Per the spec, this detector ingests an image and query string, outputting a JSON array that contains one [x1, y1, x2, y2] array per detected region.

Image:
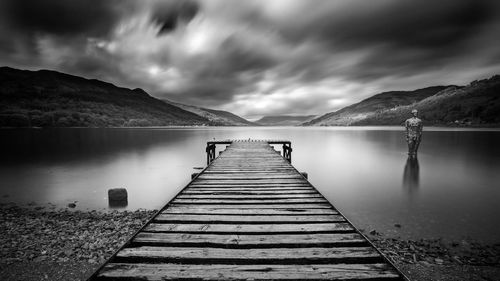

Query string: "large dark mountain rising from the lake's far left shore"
[[0, 67, 213, 127]]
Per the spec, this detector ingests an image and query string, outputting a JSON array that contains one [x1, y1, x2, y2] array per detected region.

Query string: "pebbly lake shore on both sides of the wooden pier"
[[0, 204, 500, 280]]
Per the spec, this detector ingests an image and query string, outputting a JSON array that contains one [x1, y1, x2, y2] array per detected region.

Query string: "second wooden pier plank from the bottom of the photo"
[[117, 246, 382, 264]]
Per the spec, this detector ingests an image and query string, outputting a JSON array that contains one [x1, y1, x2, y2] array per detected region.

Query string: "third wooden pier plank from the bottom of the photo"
[[132, 232, 368, 249]]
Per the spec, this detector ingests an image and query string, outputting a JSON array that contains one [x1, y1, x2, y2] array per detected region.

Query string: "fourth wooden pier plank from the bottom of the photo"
[[144, 223, 355, 234]]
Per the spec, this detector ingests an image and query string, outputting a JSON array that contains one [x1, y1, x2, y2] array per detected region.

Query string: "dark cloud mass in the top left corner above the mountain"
[[0, 0, 134, 71]]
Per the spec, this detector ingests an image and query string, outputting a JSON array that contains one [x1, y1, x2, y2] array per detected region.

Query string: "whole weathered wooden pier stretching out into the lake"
[[89, 140, 407, 281]]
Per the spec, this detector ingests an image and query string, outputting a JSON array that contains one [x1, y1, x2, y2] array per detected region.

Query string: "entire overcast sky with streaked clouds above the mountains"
[[0, 0, 500, 119]]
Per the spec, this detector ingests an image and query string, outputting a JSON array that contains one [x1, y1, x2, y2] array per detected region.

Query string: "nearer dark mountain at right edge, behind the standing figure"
[[355, 75, 500, 126]]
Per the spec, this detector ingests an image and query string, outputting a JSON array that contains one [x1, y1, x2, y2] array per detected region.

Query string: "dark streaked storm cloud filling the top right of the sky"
[[284, 0, 495, 49]]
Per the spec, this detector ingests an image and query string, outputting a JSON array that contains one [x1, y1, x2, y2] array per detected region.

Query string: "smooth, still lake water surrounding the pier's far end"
[[0, 127, 500, 242]]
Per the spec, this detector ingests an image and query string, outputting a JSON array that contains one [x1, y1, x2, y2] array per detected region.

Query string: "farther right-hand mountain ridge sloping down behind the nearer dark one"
[[303, 86, 447, 126]]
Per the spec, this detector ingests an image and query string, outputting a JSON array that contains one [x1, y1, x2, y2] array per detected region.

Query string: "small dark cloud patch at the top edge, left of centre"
[[151, 0, 200, 35]]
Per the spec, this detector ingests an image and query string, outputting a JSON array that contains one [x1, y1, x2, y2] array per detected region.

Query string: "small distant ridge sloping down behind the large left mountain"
[[163, 100, 255, 126]]
